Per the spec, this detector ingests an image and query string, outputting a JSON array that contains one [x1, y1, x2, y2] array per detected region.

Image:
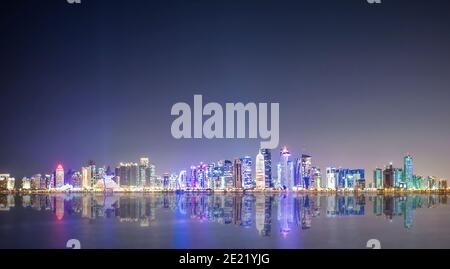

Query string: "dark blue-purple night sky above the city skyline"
[[0, 0, 450, 182]]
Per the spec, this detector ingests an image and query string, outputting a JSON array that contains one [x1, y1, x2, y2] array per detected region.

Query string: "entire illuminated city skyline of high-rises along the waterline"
[[0, 150, 447, 191]]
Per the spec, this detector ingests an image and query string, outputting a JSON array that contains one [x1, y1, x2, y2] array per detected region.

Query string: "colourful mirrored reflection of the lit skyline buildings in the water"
[[0, 193, 447, 237]]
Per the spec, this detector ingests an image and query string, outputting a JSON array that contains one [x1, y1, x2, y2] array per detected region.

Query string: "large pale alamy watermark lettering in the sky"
[[171, 95, 280, 149]]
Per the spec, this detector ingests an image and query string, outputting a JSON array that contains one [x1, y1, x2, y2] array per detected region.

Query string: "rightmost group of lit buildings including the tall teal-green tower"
[[370, 155, 447, 191]]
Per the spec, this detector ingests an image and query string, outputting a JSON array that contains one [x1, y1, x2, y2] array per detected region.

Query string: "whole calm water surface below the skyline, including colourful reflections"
[[0, 193, 450, 248]]
